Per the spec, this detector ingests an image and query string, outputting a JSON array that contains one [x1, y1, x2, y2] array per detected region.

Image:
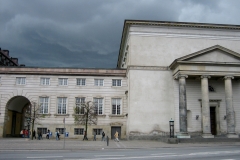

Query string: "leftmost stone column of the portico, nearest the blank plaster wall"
[[178, 75, 190, 138]]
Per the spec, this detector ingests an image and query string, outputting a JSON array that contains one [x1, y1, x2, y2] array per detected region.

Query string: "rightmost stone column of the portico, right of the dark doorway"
[[224, 76, 238, 138]]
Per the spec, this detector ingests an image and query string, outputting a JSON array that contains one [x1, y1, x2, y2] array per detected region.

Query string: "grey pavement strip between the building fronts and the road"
[[0, 138, 240, 152]]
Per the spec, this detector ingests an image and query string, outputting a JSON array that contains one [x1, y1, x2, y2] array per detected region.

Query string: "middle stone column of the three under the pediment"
[[201, 75, 214, 138]]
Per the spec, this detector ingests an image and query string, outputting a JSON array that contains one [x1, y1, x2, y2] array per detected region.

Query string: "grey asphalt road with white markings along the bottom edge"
[[0, 146, 240, 160]]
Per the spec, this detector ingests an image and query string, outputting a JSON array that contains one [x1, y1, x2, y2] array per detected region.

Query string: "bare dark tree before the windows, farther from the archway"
[[74, 101, 97, 137]]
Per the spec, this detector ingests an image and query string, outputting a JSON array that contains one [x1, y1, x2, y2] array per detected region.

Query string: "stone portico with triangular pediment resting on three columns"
[[170, 45, 240, 138]]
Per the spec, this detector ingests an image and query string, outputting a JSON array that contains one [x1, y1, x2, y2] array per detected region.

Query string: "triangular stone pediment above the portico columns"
[[177, 45, 240, 63]]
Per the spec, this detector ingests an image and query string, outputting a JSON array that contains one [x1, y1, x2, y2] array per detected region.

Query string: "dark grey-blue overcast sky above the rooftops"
[[0, 0, 240, 68]]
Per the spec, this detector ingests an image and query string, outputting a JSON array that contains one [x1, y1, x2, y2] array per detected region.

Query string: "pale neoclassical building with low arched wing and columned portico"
[[0, 20, 240, 139]]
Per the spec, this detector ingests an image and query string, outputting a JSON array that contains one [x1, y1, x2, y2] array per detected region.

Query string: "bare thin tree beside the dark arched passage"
[[25, 102, 45, 140]]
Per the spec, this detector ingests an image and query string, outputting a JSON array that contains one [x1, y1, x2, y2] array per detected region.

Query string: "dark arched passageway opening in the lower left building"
[[4, 96, 31, 137]]
